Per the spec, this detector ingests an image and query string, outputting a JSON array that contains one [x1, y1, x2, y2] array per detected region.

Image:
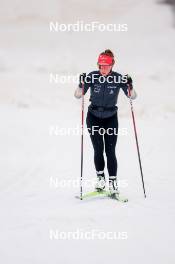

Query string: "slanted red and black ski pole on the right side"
[[128, 84, 146, 198]]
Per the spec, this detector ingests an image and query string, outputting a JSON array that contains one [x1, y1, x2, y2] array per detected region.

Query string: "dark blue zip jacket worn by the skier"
[[79, 71, 128, 118]]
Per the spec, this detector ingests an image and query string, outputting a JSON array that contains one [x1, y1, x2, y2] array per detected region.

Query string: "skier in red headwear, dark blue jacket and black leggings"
[[74, 50, 137, 195]]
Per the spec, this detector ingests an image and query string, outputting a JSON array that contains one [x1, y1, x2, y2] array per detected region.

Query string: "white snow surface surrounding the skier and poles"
[[0, 0, 175, 264]]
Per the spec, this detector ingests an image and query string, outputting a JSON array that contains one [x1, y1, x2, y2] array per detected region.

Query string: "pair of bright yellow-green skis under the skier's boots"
[[76, 191, 128, 203]]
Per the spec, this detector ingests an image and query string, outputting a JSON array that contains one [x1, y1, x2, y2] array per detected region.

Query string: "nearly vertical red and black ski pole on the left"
[[80, 82, 84, 200]]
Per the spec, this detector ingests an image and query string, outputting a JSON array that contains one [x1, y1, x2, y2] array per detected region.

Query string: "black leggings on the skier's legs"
[[86, 112, 118, 176]]
